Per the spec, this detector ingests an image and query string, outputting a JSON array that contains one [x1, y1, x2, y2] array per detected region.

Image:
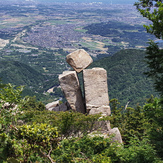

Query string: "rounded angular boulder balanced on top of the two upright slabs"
[[66, 49, 93, 72]]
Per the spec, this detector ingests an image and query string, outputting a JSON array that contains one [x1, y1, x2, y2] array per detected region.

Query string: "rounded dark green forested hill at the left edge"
[[0, 61, 46, 87]]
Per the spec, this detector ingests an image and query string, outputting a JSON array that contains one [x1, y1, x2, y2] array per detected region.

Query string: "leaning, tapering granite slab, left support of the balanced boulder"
[[59, 71, 85, 113]]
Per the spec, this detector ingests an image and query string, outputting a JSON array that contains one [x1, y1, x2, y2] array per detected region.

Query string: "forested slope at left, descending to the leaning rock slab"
[[0, 60, 59, 100]]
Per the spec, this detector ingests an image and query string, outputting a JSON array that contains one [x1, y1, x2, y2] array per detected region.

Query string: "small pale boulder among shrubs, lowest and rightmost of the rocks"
[[109, 127, 122, 143]]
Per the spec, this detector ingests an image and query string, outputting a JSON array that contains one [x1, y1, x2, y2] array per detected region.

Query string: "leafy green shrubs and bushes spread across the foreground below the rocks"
[[0, 84, 162, 163]]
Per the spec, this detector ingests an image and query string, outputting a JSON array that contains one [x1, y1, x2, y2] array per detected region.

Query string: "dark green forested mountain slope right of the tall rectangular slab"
[[91, 49, 156, 106]]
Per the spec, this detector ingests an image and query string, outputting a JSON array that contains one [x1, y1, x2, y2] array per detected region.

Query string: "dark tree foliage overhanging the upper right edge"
[[135, 0, 163, 96]]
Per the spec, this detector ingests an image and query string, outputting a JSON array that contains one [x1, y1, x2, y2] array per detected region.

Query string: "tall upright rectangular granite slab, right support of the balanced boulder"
[[83, 68, 110, 115]]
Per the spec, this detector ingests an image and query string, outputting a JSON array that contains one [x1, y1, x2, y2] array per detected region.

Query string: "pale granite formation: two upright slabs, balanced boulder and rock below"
[[59, 49, 122, 143]]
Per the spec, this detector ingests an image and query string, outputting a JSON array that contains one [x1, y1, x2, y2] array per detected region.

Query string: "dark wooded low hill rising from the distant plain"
[[84, 21, 155, 52]]
